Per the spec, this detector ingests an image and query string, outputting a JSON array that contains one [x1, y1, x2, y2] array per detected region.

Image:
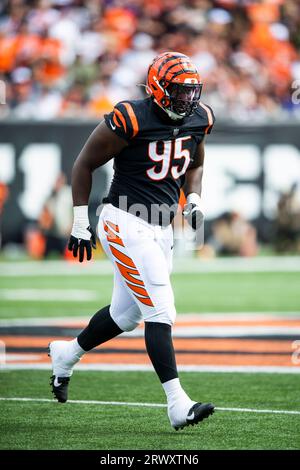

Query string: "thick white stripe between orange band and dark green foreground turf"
[[1, 363, 300, 374]]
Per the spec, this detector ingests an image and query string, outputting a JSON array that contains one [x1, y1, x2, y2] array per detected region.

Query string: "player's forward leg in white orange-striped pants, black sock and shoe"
[[99, 208, 213, 428]]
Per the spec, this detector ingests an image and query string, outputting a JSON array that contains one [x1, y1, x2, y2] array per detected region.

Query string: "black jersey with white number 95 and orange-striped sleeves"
[[104, 98, 214, 225]]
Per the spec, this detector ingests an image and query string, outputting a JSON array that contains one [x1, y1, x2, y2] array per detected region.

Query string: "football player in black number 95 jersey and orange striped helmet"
[[49, 52, 214, 430]]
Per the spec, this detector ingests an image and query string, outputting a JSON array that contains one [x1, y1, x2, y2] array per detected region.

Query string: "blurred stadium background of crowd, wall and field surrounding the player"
[[0, 0, 300, 449]]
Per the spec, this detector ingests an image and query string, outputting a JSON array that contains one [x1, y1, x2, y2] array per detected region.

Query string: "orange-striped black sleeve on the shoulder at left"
[[104, 101, 139, 142]]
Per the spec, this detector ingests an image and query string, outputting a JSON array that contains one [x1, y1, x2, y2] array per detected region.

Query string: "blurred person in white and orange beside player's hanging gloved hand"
[[39, 173, 73, 257]]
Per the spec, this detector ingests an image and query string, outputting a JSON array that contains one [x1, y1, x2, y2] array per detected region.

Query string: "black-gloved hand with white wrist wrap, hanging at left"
[[68, 206, 96, 263]]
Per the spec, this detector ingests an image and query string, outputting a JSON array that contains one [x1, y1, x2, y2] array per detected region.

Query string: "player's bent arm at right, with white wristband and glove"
[[183, 139, 204, 230]]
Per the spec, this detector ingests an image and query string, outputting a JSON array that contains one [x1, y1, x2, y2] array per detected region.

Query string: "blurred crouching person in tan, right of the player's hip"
[[203, 212, 258, 257]]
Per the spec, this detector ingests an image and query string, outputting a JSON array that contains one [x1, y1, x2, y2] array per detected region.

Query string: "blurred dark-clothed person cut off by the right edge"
[[275, 184, 300, 253]]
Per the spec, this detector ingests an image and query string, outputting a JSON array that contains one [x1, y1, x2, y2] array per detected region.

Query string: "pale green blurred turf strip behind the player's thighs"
[[0, 272, 300, 318]]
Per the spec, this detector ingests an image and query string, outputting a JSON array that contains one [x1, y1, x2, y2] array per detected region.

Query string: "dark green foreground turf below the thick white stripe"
[[0, 371, 300, 450]]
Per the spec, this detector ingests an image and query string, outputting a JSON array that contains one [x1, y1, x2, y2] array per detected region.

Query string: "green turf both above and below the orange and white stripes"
[[0, 265, 300, 450]]
